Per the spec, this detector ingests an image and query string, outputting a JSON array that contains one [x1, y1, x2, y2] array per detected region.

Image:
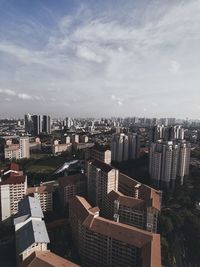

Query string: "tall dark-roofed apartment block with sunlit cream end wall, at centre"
[[86, 159, 119, 212]]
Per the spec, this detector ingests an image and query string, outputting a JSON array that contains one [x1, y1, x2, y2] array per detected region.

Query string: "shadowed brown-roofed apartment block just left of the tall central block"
[[58, 174, 87, 206]]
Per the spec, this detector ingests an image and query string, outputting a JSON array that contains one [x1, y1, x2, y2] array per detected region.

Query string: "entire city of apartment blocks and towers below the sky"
[[0, 113, 200, 267]]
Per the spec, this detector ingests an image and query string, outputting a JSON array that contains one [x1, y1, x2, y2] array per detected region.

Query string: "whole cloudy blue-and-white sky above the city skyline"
[[0, 0, 200, 119]]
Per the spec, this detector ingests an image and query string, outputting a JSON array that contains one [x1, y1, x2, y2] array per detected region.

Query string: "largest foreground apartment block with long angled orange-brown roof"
[[69, 196, 161, 267]]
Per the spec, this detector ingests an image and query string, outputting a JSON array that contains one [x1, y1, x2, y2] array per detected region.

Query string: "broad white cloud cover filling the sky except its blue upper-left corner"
[[0, 0, 200, 116]]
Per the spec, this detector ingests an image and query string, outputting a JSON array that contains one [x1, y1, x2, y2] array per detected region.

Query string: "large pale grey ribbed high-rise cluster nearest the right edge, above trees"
[[149, 140, 191, 189]]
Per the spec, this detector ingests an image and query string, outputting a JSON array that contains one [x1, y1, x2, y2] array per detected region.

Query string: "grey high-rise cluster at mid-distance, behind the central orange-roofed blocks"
[[111, 133, 140, 162]]
